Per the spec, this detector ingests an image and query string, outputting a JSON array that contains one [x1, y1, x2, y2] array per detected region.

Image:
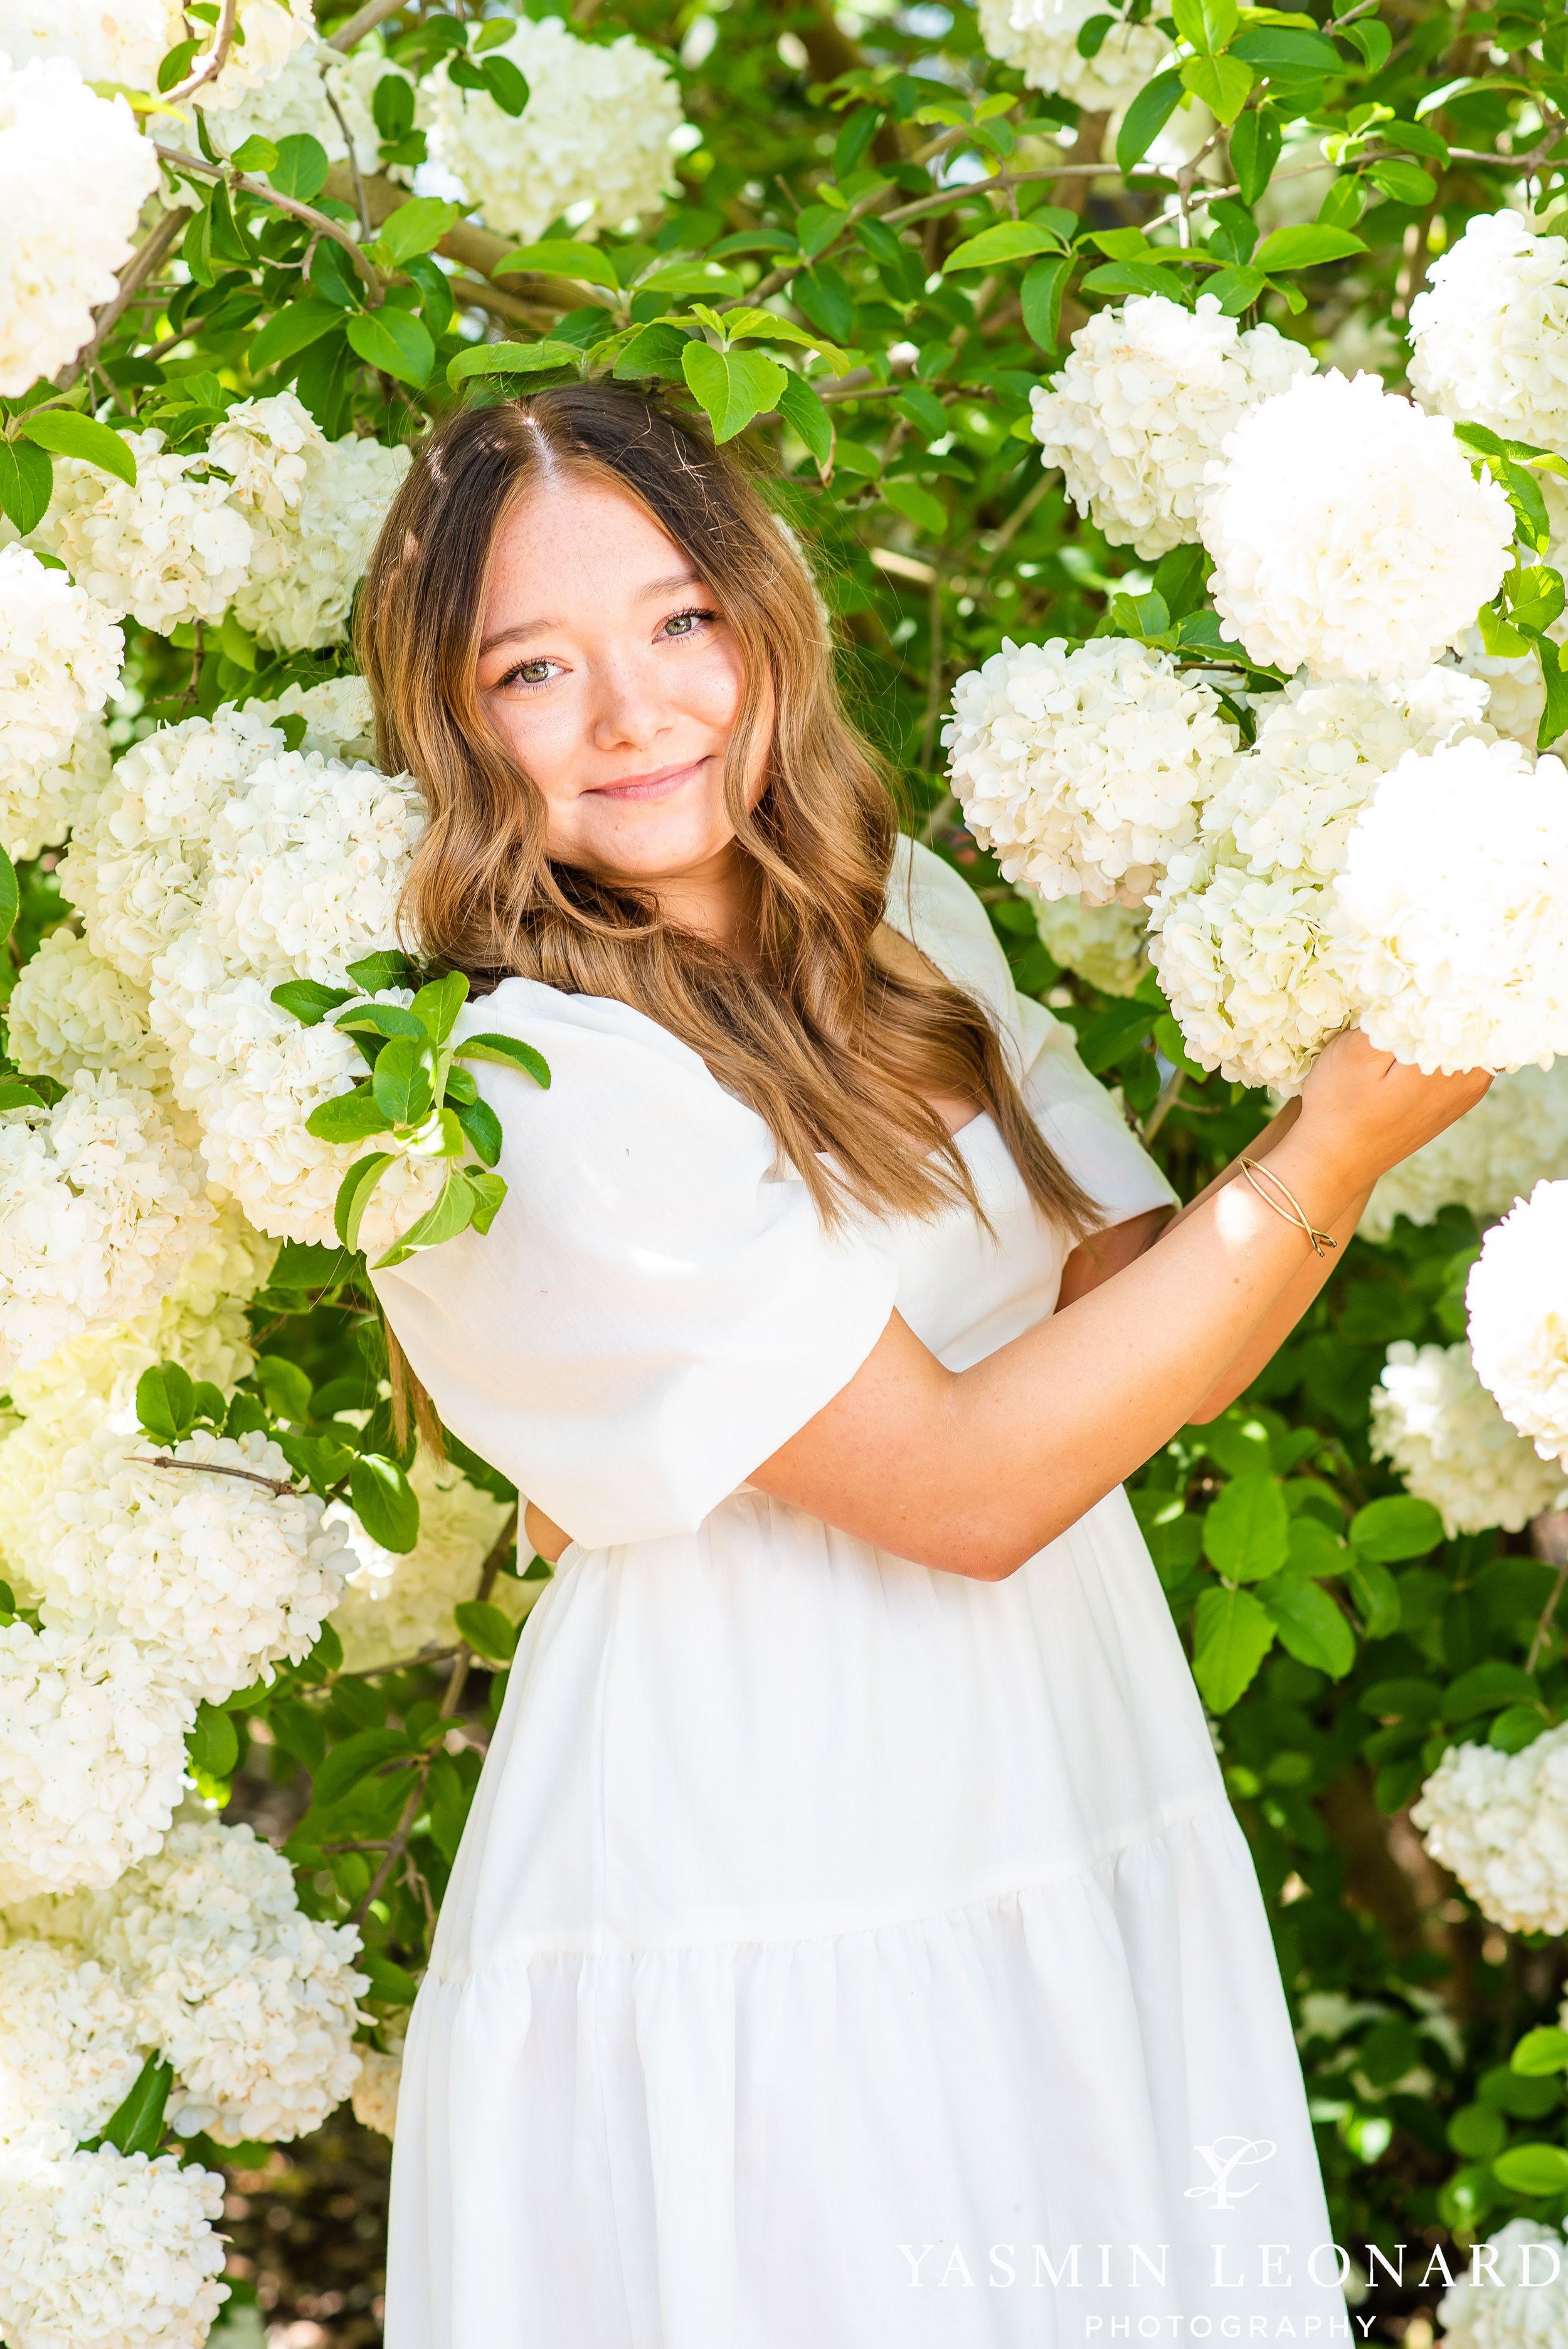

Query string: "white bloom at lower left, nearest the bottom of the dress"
[[92, 1816, 369, 2145]]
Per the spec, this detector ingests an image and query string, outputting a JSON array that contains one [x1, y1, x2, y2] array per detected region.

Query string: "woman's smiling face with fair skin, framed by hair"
[[479, 477, 772, 883]]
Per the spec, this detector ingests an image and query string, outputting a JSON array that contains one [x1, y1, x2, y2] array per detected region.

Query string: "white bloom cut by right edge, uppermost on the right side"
[[1411, 211, 1568, 456]]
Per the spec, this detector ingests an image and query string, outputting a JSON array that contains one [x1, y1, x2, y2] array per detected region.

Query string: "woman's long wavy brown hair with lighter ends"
[[357, 383, 1098, 1238]]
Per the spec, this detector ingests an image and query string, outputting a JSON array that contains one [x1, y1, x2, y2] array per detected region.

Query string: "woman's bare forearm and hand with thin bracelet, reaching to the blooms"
[[751, 1031, 1488, 1581]]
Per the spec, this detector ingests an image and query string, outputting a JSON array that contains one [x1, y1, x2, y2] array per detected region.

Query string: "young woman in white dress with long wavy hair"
[[361, 385, 1486, 2349]]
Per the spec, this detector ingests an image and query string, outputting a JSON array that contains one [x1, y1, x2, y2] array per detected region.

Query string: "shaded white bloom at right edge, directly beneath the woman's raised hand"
[[1359, 1057, 1568, 1240]]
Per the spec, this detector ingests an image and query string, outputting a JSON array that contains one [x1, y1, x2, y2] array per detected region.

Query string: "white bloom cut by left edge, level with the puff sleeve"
[[0, 1069, 214, 1374]]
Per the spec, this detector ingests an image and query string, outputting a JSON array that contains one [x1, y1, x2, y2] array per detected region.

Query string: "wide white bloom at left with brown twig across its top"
[[21, 1426, 354, 1705]]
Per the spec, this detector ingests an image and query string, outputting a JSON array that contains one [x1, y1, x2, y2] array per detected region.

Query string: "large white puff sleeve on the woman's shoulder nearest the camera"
[[373, 980, 899, 1548]]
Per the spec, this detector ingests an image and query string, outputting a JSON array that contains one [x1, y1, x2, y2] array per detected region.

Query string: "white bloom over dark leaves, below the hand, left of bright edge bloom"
[[1371, 1339, 1565, 1536]]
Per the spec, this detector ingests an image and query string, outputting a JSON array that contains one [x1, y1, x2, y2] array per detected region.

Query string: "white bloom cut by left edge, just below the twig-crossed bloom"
[[0, 1623, 195, 1901]]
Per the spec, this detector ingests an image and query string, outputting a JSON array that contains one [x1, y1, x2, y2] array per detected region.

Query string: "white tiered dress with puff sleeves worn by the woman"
[[376, 851, 1347, 2349]]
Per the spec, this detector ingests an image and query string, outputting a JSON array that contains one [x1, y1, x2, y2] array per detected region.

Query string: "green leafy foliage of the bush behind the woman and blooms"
[[0, 0, 1568, 2337]]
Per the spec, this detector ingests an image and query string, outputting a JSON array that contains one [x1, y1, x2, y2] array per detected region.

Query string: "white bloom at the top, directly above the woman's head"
[[420, 16, 681, 240]]
